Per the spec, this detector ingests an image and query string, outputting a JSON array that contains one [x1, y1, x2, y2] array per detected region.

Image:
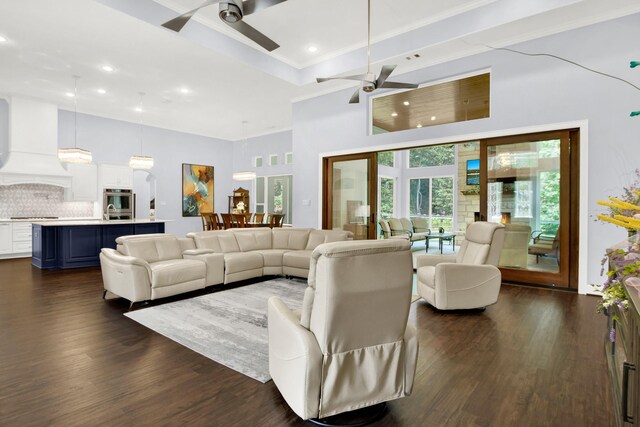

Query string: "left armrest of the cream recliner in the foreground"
[[268, 297, 322, 420]]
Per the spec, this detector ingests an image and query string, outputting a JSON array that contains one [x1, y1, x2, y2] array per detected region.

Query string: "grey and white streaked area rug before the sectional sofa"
[[125, 278, 307, 383]]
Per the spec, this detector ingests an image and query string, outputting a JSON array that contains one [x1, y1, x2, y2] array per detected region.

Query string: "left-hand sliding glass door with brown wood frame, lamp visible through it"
[[322, 153, 378, 240]]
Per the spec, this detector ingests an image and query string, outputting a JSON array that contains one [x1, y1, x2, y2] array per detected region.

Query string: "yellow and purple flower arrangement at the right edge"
[[594, 169, 640, 342]]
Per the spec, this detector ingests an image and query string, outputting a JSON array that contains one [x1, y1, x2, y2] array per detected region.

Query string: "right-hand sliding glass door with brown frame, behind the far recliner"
[[480, 131, 577, 287]]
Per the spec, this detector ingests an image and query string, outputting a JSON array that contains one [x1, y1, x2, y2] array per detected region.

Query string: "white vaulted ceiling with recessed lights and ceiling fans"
[[0, 0, 640, 140]]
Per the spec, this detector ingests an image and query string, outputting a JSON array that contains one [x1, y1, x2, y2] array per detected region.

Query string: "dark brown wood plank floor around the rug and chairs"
[[0, 259, 612, 426]]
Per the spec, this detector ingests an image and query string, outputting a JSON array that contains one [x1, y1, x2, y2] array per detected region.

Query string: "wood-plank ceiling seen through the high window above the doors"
[[373, 73, 490, 132]]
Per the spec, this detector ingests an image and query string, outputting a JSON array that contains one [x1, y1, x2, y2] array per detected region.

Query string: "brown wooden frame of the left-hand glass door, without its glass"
[[322, 152, 378, 240]]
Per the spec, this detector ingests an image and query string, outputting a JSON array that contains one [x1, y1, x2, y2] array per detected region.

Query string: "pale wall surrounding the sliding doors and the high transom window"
[[293, 14, 640, 292]]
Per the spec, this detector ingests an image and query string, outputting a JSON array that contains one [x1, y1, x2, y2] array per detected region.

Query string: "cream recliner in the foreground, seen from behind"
[[268, 239, 418, 420]]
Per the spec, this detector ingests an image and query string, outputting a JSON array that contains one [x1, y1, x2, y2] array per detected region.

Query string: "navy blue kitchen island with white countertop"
[[31, 219, 167, 269]]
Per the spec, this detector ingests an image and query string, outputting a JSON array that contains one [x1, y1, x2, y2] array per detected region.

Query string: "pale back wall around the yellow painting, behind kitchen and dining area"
[[56, 110, 233, 236]]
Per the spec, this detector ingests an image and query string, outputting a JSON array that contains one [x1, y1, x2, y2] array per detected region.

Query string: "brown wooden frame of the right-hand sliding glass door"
[[480, 130, 579, 289]]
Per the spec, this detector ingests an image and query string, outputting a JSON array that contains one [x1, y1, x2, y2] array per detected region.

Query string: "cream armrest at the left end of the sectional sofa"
[[100, 248, 151, 302]]
